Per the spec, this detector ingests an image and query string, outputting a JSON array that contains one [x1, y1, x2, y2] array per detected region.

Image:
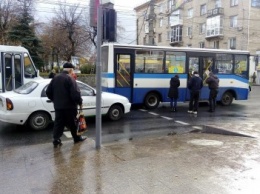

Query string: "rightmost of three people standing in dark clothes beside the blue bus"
[[206, 72, 219, 112]]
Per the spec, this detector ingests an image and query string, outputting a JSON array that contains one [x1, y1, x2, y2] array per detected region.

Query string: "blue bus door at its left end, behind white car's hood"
[[114, 49, 134, 102]]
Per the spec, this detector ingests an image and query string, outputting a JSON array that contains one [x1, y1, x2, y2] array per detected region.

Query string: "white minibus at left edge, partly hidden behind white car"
[[0, 45, 43, 92]]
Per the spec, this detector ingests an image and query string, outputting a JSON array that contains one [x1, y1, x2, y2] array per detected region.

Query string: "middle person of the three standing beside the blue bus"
[[188, 71, 203, 114]]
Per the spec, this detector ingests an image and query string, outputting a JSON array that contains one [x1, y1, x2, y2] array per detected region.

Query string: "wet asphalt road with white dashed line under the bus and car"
[[0, 86, 260, 148]]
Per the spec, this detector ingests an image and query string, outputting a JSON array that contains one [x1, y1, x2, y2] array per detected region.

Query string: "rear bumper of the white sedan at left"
[[0, 112, 28, 125]]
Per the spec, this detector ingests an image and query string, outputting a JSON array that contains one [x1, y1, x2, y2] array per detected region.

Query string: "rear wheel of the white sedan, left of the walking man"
[[28, 112, 50, 130]]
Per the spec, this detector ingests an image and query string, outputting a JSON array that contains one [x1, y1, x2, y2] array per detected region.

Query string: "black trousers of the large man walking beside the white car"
[[53, 109, 80, 140]]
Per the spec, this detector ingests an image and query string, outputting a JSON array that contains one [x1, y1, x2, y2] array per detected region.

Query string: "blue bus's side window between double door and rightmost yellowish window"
[[215, 54, 233, 74]]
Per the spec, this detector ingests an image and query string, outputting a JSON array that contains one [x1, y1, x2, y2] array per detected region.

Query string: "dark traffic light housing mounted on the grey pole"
[[103, 8, 117, 42]]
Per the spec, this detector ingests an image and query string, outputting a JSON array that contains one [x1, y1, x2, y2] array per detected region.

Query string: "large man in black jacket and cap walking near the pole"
[[46, 63, 86, 147]]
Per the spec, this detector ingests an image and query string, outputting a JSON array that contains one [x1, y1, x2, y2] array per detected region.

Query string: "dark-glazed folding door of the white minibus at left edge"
[[1, 53, 23, 92]]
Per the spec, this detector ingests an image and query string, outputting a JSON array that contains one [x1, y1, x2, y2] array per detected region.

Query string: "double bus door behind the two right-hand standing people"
[[186, 53, 215, 100]]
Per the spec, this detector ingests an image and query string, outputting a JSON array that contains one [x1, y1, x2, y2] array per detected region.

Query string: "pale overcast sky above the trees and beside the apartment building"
[[35, 0, 149, 44]]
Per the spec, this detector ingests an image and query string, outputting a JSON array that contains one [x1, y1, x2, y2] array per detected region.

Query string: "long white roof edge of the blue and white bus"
[[103, 43, 250, 55]]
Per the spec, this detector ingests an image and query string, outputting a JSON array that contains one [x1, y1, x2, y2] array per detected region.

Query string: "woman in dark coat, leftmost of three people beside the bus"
[[168, 75, 180, 112]]
